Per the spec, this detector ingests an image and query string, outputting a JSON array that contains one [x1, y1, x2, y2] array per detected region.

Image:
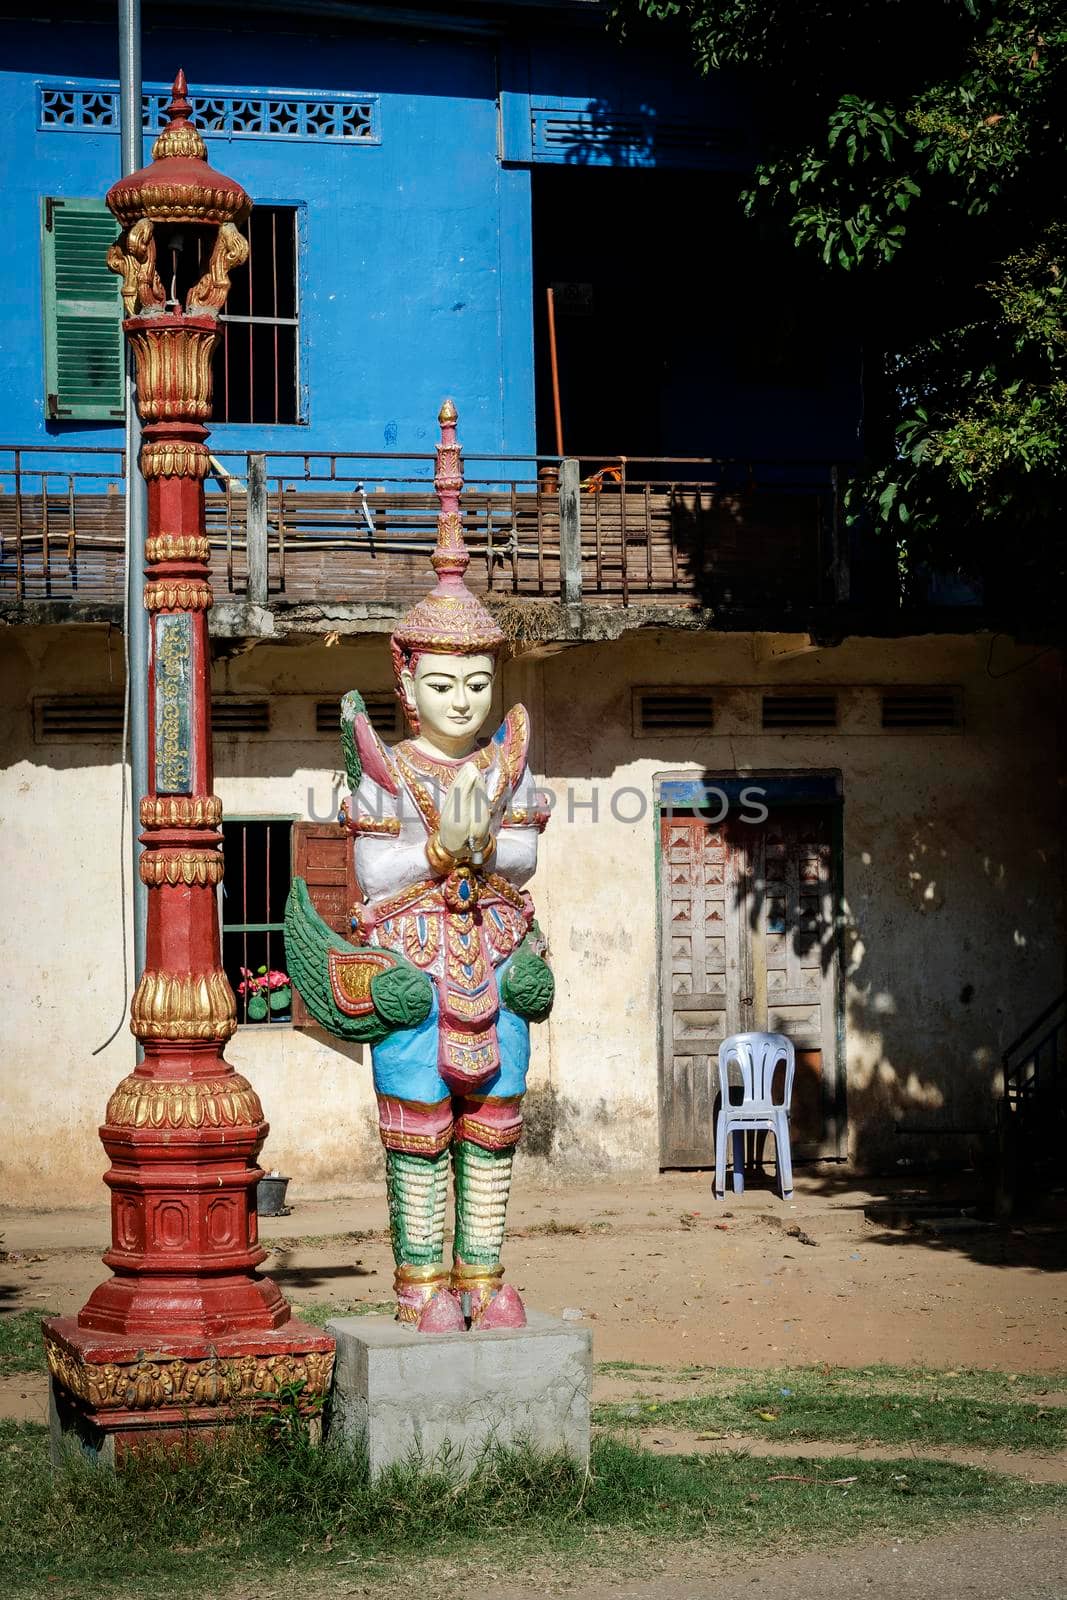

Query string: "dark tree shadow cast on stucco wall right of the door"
[[726, 806, 1056, 1203]]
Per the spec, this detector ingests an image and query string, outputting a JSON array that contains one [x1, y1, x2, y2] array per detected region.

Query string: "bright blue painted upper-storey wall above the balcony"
[[0, 13, 859, 456]]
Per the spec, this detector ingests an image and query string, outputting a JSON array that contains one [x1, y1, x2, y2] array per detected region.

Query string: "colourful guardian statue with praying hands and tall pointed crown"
[[285, 402, 553, 1333]]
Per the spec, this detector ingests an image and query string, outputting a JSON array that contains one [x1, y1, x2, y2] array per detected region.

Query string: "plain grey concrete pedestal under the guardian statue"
[[326, 1312, 592, 1474]]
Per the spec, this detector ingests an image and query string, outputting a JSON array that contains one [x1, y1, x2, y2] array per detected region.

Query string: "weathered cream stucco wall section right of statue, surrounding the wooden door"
[[539, 634, 1062, 1168]]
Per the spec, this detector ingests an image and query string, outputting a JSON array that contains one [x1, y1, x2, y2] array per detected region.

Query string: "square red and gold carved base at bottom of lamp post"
[[43, 1317, 333, 1466]]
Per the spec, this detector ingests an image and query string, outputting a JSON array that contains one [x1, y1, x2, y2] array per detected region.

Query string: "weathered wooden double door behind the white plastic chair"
[[661, 806, 841, 1166]]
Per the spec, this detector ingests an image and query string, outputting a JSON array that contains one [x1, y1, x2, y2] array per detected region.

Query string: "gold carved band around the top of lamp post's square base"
[[45, 1333, 333, 1411]]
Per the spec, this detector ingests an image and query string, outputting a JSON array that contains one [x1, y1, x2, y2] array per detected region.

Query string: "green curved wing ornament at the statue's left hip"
[[285, 876, 434, 1045]]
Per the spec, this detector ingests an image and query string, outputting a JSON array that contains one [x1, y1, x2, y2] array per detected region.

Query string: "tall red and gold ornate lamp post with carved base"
[[45, 72, 333, 1459]]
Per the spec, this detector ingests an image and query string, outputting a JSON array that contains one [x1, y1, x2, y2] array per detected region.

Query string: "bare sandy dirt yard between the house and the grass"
[[0, 1171, 1067, 1416]]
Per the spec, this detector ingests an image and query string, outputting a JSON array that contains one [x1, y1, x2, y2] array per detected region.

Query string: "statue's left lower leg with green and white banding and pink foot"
[[386, 1150, 448, 1323]]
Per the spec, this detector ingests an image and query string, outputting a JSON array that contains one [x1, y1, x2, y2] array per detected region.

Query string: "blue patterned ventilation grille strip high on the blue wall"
[[37, 83, 381, 146]]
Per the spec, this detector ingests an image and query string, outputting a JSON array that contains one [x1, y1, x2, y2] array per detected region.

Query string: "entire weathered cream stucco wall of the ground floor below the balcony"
[[0, 626, 1062, 1205]]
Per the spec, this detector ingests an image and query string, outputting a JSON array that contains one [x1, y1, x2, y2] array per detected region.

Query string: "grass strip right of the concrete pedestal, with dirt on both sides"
[[593, 1368, 1067, 1450]]
